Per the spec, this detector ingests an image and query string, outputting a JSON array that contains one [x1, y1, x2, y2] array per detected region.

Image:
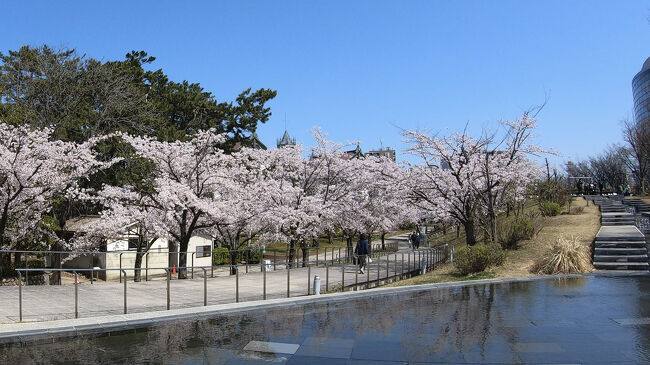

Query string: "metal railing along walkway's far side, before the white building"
[[0, 242, 398, 285]]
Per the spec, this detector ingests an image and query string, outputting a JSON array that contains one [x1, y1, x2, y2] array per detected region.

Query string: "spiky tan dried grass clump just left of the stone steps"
[[531, 236, 591, 274]]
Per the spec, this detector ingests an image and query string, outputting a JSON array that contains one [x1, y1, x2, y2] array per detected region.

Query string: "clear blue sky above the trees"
[[0, 0, 650, 164]]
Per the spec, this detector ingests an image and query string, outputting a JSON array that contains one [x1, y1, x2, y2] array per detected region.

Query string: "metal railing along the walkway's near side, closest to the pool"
[[16, 245, 449, 322]]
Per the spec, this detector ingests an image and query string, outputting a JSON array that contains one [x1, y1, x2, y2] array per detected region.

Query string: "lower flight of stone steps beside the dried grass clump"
[[594, 225, 649, 270]]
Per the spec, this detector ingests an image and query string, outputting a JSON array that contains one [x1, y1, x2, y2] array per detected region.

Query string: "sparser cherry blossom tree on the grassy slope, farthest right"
[[403, 112, 547, 245]]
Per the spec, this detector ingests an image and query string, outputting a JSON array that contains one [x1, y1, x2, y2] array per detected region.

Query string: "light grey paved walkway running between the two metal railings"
[[0, 235, 442, 323]]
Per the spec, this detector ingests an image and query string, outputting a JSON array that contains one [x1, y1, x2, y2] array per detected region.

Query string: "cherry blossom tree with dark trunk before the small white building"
[[87, 130, 232, 279]]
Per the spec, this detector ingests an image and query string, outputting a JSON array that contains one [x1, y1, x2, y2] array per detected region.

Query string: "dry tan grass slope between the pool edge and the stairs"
[[388, 198, 600, 286]]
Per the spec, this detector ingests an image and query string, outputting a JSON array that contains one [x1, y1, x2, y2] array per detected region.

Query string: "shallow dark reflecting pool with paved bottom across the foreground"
[[0, 275, 650, 365]]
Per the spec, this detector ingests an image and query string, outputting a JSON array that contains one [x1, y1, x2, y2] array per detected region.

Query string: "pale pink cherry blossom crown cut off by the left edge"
[[0, 123, 116, 249]]
